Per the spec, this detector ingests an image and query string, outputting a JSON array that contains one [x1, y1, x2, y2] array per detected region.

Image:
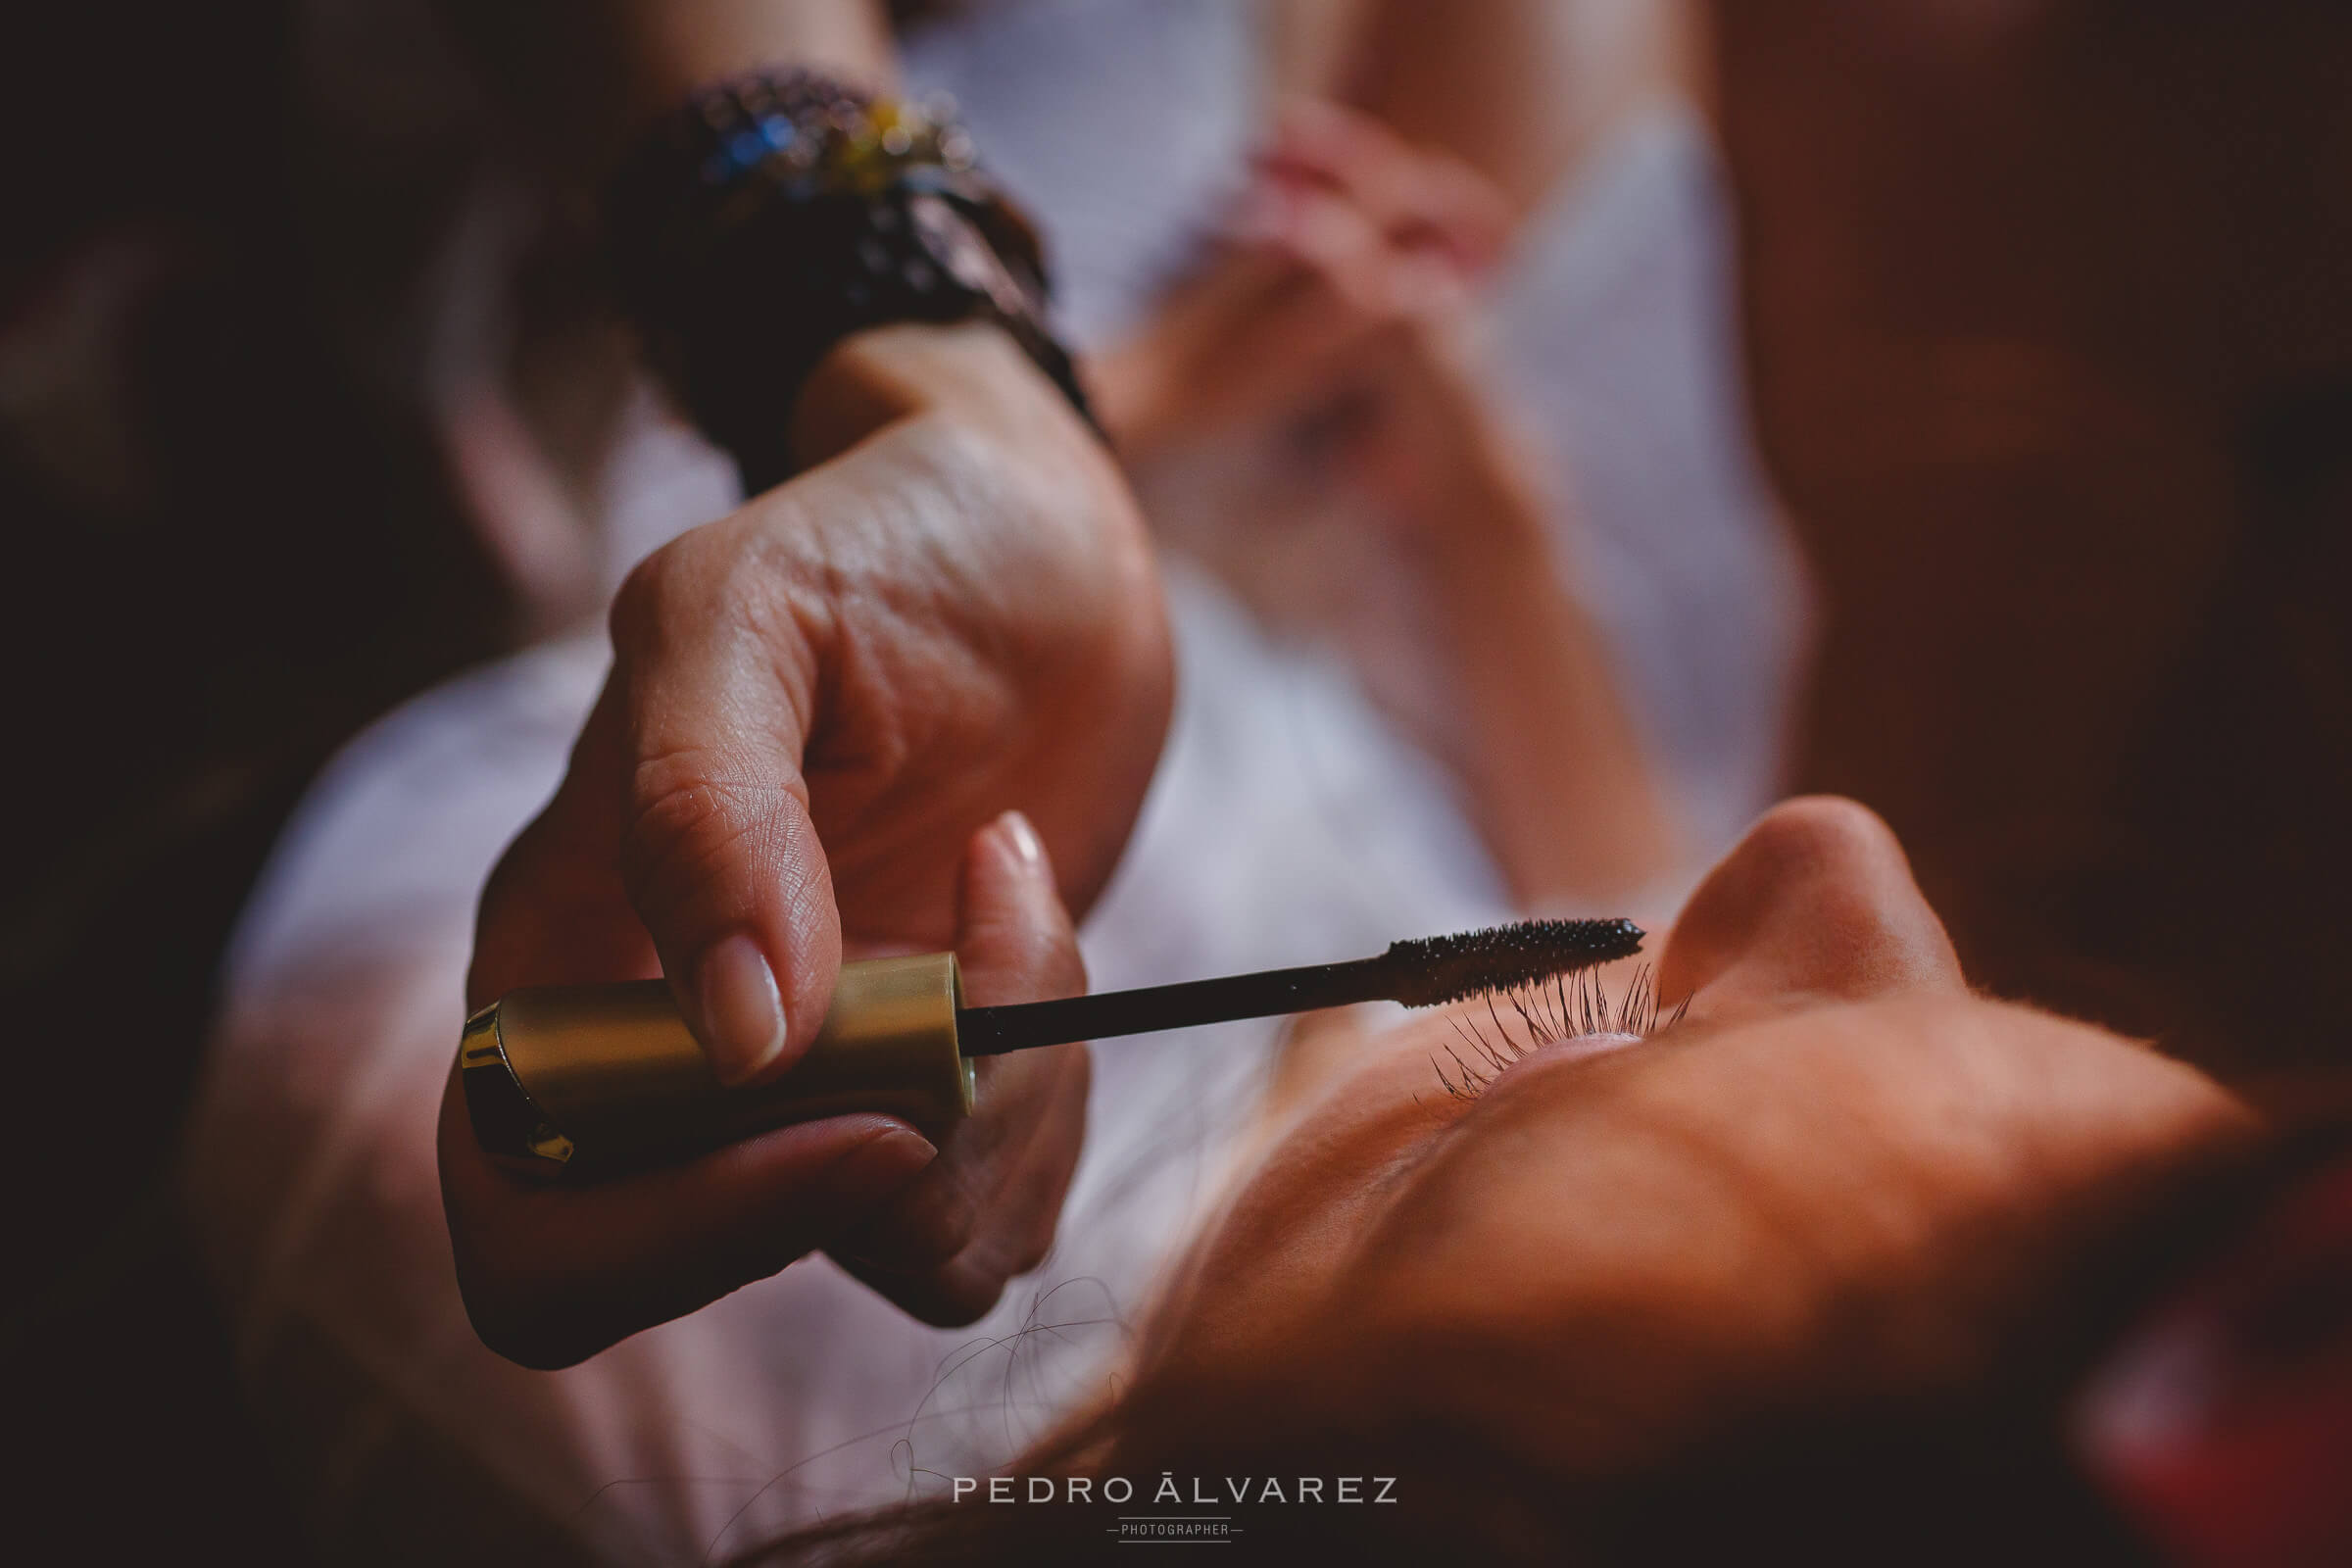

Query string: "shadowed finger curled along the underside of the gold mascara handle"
[[440, 1072, 936, 1368]]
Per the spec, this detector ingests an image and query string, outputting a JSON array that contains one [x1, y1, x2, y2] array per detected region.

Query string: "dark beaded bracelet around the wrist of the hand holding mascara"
[[610, 71, 1101, 491]]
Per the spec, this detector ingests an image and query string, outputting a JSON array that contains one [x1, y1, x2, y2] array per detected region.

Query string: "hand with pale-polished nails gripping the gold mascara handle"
[[442, 326, 1169, 1366]]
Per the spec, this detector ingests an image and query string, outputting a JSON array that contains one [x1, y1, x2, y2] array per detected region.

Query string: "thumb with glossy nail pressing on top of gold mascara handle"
[[612, 513, 842, 1084]]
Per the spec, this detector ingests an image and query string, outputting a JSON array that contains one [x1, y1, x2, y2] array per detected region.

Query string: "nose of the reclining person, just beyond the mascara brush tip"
[[1658, 795, 1964, 1015]]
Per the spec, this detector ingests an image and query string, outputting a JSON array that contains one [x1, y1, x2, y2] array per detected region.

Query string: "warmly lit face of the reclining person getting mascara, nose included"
[[1109, 800, 2246, 1479]]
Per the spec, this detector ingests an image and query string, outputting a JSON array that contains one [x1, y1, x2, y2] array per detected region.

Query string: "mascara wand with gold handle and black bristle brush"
[[459, 919, 1642, 1175]]
